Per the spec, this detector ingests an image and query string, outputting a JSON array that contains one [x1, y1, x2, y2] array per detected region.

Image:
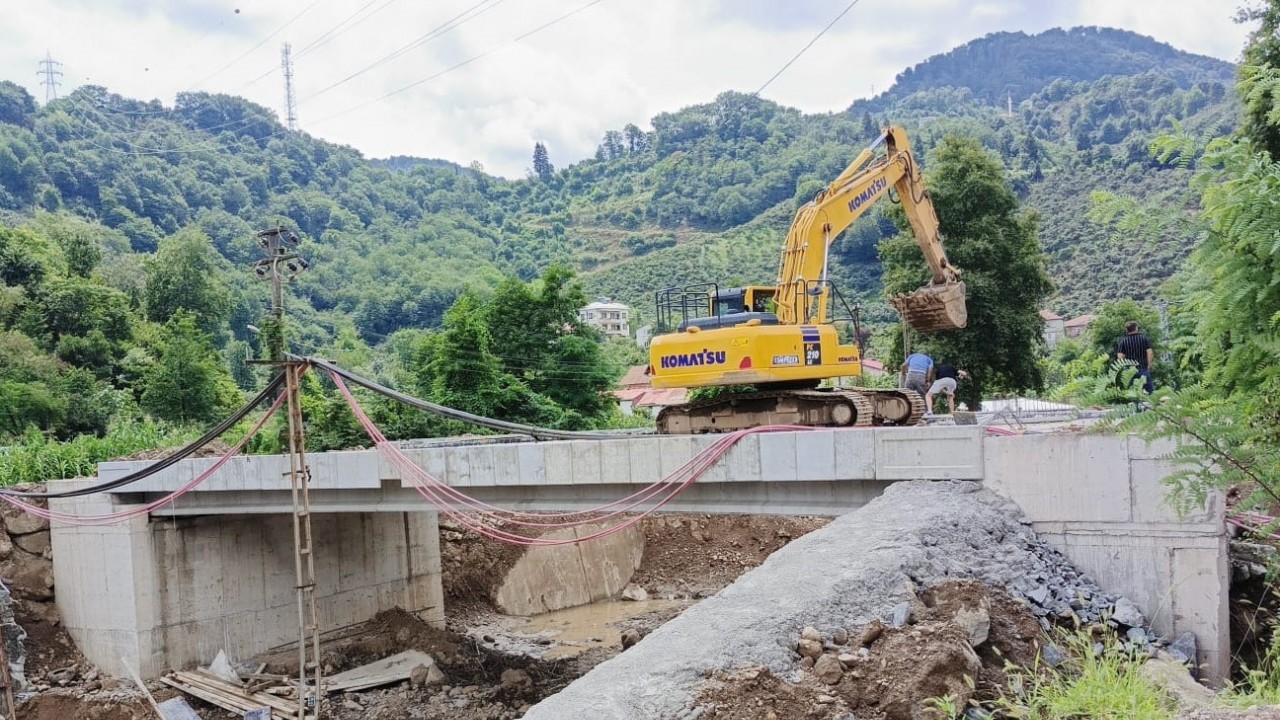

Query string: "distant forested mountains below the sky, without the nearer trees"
[[0, 28, 1238, 350]]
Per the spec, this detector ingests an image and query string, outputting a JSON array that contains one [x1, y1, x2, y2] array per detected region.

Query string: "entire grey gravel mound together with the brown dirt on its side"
[[526, 482, 1198, 720]]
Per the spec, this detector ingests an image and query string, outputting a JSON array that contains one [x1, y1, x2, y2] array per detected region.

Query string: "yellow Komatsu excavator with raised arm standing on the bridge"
[[649, 127, 968, 434]]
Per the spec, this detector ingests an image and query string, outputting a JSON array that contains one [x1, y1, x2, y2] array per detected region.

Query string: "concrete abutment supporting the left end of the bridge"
[[51, 483, 444, 678]]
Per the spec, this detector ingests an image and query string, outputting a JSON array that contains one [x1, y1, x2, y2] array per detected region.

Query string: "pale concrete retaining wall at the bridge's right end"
[[983, 434, 1230, 683]]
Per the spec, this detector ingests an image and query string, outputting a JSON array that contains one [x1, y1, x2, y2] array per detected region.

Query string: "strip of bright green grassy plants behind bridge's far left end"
[[0, 420, 200, 486]]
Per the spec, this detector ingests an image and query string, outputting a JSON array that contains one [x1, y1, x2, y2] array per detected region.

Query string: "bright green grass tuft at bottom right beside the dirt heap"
[[993, 630, 1176, 720]]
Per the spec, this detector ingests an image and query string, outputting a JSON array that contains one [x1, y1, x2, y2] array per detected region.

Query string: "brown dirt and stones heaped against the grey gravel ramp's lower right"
[[700, 580, 1042, 720]]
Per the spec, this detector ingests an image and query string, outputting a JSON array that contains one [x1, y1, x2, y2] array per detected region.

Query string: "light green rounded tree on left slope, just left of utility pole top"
[[142, 227, 232, 334]]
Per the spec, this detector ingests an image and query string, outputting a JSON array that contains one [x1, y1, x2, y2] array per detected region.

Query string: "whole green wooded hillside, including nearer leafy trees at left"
[[0, 28, 1239, 448]]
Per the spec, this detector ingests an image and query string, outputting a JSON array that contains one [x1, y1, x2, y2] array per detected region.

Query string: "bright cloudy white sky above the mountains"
[[0, 0, 1245, 177]]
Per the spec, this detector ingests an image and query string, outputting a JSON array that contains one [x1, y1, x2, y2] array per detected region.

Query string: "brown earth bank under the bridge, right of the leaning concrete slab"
[[632, 515, 831, 597]]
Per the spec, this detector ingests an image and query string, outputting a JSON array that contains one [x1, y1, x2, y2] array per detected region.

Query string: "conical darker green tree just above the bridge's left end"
[[142, 309, 238, 423]]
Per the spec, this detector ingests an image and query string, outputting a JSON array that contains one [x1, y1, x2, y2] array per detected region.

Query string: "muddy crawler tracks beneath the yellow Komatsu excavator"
[[658, 388, 924, 434]]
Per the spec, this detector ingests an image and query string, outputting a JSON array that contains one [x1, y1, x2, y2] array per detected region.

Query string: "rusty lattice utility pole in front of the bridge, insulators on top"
[[253, 227, 321, 720]]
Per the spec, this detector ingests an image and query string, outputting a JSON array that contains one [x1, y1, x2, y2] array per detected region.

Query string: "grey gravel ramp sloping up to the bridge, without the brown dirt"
[[525, 482, 1142, 720]]
